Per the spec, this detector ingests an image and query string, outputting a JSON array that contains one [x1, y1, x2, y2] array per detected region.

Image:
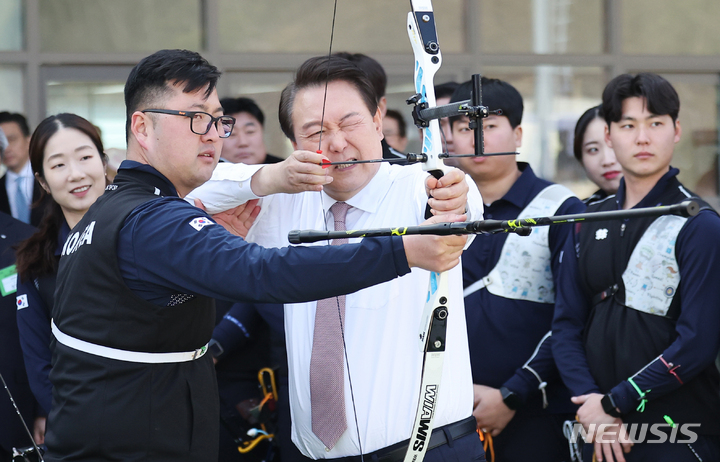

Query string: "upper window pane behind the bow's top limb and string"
[[219, 0, 464, 54]]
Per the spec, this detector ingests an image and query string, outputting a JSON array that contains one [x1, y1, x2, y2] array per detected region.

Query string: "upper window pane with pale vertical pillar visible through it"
[[474, 0, 604, 54]]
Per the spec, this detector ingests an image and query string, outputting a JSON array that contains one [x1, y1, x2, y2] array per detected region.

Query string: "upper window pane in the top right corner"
[[622, 0, 720, 55]]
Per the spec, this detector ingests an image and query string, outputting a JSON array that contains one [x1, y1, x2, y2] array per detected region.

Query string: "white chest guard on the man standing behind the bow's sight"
[[463, 184, 574, 303]]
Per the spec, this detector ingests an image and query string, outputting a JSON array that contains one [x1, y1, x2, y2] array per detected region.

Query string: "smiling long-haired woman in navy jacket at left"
[[17, 114, 107, 441]]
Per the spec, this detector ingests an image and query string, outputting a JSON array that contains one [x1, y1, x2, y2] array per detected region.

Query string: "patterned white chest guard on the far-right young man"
[[623, 215, 687, 316]]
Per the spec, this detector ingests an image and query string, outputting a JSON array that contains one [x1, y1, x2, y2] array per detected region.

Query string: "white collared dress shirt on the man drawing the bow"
[[247, 164, 483, 459]]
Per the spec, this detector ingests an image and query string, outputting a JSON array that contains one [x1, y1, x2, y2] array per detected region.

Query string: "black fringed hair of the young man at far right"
[[601, 72, 680, 128]]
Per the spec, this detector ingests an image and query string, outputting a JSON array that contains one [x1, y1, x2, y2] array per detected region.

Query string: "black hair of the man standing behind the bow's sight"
[[450, 77, 524, 128]]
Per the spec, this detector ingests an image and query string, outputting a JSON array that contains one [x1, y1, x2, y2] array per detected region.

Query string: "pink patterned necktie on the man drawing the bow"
[[310, 202, 350, 449]]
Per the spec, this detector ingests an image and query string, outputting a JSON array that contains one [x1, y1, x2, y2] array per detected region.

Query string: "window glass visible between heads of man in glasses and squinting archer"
[[220, 72, 293, 157]]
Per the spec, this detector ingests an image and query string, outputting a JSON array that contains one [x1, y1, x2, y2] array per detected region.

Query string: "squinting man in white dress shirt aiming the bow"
[[248, 57, 484, 461]]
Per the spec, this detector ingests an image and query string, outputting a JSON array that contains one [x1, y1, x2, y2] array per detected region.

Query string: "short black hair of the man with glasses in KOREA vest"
[[125, 50, 220, 140]]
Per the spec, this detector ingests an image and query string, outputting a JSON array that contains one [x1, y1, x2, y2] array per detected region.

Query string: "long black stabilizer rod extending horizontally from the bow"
[[288, 200, 700, 244]]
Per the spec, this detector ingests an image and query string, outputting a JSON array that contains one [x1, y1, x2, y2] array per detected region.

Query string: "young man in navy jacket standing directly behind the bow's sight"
[[451, 78, 585, 461]]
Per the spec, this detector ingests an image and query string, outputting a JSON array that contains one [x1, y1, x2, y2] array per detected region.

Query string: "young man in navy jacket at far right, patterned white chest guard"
[[553, 73, 720, 462]]
